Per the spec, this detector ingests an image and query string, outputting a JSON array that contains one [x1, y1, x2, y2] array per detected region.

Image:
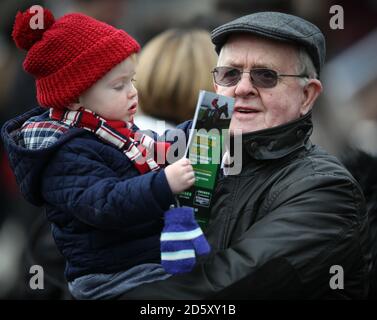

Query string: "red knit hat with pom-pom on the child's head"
[[12, 5, 140, 108]]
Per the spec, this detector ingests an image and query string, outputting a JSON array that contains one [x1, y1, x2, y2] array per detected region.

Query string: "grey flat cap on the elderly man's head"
[[211, 12, 326, 75]]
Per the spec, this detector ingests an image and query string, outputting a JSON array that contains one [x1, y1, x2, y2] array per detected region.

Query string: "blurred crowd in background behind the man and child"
[[0, 0, 377, 299]]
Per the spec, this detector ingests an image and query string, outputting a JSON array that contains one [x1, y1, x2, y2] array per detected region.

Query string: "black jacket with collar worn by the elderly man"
[[122, 113, 371, 299]]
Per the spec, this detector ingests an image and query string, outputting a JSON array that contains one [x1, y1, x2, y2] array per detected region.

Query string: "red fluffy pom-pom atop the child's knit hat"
[[12, 9, 55, 50]]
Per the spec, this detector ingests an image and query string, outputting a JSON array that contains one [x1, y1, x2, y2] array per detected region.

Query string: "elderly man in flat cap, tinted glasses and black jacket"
[[123, 12, 370, 299]]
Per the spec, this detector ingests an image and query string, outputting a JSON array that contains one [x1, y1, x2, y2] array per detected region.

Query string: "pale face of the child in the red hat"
[[80, 57, 138, 121]]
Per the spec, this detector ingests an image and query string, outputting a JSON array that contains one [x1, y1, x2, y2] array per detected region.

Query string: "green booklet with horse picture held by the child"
[[177, 90, 234, 229]]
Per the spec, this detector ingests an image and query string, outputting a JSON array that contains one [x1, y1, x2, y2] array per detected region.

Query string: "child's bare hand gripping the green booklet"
[[165, 158, 195, 194]]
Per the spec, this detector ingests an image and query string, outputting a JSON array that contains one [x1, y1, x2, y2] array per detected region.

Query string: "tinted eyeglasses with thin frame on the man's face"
[[211, 67, 308, 88]]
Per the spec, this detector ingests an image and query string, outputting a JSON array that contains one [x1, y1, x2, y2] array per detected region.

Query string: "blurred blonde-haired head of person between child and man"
[[135, 29, 217, 134]]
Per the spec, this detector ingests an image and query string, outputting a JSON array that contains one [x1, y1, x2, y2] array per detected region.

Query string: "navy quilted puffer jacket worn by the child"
[[2, 108, 187, 281]]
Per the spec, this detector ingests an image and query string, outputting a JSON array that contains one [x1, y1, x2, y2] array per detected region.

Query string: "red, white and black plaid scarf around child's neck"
[[50, 108, 170, 174]]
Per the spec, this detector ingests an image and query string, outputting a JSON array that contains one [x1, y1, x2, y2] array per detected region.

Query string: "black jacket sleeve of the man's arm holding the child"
[[119, 172, 367, 299]]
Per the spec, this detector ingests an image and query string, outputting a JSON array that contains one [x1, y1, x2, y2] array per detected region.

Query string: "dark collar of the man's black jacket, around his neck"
[[242, 111, 313, 160]]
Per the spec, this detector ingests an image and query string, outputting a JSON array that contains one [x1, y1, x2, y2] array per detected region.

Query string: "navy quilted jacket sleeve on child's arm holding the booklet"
[[42, 139, 173, 229]]
